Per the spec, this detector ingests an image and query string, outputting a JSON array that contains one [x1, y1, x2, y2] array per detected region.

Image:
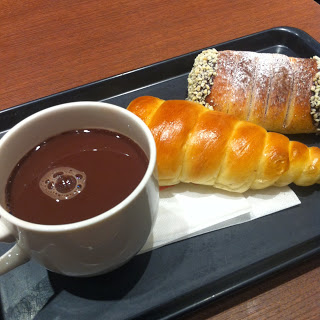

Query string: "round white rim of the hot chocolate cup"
[[0, 101, 157, 233]]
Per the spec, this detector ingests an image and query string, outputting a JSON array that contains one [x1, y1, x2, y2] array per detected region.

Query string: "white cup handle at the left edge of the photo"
[[0, 218, 30, 275]]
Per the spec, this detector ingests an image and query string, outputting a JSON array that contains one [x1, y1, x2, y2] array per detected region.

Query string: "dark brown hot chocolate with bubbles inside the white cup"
[[6, 129, 148, 225]]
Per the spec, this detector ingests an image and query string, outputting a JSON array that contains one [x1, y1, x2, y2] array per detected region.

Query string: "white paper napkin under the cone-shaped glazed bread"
[[140, 184, 301, 253]]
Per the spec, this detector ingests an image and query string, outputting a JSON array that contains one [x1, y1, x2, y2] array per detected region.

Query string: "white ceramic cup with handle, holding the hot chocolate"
[[0, 102, 159, 276]]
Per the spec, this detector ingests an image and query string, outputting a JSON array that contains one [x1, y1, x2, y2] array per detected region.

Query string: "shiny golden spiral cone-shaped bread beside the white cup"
[[128, 96, 320, 192]]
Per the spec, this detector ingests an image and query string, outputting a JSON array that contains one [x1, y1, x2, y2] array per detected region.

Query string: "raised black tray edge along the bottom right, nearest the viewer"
[[144, 235, 320, 320]]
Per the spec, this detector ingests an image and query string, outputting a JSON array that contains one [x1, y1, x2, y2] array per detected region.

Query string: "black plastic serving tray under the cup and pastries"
[[0, 27, 320, 320]]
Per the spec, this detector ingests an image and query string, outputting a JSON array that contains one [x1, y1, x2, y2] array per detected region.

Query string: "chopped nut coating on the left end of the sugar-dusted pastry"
[[187, 49, 218, 109]]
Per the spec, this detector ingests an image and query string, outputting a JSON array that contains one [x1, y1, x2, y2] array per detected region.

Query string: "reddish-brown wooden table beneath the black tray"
[[0, 0, 320, 320]]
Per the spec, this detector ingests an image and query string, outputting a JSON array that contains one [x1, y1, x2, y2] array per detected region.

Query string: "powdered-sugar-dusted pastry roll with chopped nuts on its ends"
[[187, 49, 320, 134]]
